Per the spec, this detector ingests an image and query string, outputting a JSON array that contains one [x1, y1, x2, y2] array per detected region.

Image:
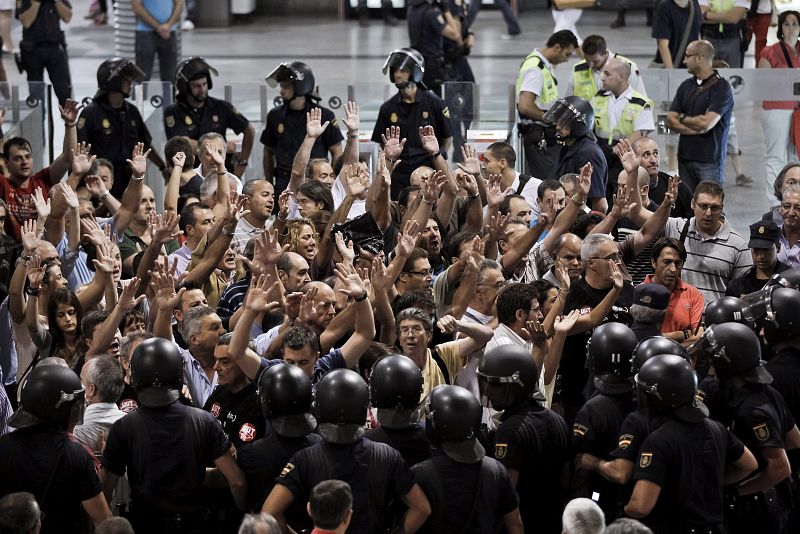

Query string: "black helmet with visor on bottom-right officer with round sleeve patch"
[[692, 323, 772, 384]]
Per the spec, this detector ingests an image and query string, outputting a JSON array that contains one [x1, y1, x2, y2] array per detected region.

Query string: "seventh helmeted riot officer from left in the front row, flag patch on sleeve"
[[478, 345, 569, 532]]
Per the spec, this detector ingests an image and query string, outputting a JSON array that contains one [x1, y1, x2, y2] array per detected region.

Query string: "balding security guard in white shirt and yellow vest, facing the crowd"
[[591, 58, 656, 204]]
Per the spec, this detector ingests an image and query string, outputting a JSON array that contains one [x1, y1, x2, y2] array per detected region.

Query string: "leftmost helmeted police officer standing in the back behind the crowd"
[[78, 57, 166, 198]]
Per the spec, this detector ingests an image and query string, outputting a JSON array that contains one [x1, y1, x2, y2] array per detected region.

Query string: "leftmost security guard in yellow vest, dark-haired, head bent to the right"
[[515, 30, 578, 184]]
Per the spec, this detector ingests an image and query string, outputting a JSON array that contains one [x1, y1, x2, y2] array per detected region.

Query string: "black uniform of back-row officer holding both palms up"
[[372, 89, 453, 200]]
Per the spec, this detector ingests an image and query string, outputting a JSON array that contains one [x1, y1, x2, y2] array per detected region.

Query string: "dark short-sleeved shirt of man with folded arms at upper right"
[[669, 71, 733, 163]]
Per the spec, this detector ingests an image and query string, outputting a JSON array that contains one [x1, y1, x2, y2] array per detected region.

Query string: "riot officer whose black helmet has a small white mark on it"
[[572, 323, 637, 523]]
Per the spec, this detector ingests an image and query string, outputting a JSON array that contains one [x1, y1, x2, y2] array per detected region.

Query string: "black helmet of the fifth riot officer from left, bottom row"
[[369, 354, 423, 428]]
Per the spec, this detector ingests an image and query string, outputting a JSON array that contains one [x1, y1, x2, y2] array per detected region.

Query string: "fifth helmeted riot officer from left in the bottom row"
[[364, 354, 431, 466]]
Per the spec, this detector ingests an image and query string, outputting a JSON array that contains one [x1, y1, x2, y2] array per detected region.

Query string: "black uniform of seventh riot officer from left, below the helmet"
[[494, 401, 570, 532]]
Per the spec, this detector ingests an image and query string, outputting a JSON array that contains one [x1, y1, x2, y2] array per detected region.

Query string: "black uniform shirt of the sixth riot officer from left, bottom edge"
[[411, 449, 519, 534]]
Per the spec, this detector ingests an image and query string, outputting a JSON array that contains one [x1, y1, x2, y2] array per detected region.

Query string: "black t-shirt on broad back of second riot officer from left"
[[103, 402, 231, 512]]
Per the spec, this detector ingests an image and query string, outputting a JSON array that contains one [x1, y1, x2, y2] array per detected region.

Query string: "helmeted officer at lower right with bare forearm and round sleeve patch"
[[701, 323, 800, 533]]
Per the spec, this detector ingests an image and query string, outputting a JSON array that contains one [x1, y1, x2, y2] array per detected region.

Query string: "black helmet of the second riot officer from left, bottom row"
[[131, 337, 183, 408]]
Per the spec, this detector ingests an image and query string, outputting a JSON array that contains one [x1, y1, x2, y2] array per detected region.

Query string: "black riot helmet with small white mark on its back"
[[586, 323, 636, 395]]
